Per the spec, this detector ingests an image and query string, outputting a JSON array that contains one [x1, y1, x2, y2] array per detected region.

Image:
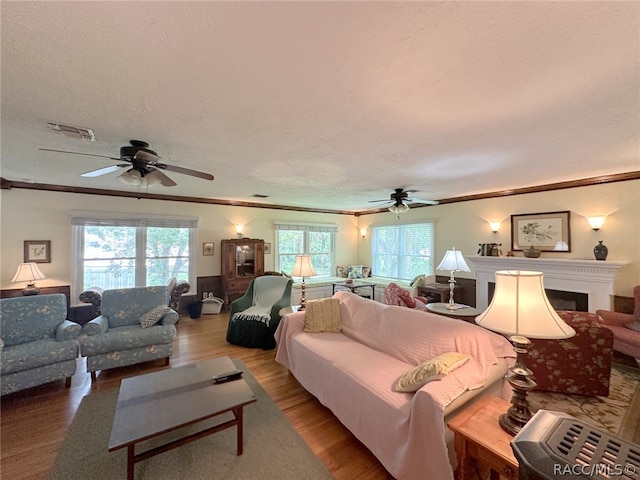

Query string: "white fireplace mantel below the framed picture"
[[465, 255, 629, 312]]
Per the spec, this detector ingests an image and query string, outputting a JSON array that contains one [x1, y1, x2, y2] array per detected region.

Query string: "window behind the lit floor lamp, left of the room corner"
[[275, 222, 338, 277]]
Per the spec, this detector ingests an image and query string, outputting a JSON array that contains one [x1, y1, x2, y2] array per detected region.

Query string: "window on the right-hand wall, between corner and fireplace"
[[372, 222, 435, 280]]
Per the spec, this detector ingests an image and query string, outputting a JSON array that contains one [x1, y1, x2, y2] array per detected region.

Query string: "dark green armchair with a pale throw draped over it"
[[227, 275, 293, 350]]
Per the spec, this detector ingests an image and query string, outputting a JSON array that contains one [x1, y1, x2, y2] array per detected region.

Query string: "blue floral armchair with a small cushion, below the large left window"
[[80, 286, 178, 381]]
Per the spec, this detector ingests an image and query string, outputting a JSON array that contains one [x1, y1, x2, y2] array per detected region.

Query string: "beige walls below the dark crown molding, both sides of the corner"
[[0, 180, 640, 304]]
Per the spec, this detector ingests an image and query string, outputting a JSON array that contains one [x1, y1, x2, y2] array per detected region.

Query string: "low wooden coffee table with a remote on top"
[[109, 357, 256, 480]]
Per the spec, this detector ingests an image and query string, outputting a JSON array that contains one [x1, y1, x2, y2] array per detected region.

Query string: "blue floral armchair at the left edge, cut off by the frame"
[[0, 293, 82, 395]]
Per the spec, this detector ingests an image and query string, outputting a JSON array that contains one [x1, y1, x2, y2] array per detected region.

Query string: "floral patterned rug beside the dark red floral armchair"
[[529, 363, 640, 444]]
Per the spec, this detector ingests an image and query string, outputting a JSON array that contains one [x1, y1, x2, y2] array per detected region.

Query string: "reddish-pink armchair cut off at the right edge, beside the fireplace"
[[596, 285, 640, 367]]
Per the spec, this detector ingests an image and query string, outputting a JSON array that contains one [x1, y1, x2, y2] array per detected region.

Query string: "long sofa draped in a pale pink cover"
[[275, 292, 514, 480]]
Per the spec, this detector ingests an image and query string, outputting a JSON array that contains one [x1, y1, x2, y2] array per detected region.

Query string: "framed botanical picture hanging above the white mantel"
[[511, 210, 571, 252]]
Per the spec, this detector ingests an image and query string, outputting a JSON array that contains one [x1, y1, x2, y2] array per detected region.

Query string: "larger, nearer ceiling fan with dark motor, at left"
[[40, 140, 214, 187]]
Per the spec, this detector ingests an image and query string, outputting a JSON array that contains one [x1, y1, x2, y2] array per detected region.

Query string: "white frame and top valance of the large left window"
[[70, 212, 198, 298]]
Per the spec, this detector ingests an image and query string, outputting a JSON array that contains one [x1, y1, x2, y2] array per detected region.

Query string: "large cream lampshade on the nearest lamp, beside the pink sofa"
[[476, 270, 576, 339]]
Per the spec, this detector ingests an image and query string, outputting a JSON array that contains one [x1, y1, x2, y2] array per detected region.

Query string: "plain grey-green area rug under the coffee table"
[[49, 359, 333, 480]]
